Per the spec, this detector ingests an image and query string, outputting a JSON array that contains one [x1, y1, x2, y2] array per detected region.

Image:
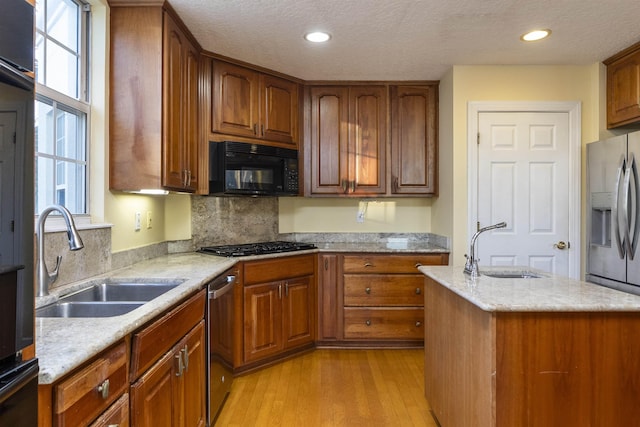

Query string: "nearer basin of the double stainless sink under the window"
[[36, 301, 144, 317]]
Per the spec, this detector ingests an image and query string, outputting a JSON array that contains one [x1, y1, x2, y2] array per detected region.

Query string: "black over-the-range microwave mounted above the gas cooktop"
[[209, 141, 298, 196]]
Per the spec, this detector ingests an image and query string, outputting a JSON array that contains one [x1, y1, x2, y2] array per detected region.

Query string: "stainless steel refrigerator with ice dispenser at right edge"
[[586, 132, 640, 295]]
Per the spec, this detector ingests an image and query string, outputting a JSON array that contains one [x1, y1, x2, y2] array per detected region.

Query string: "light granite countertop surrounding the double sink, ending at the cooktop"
[[36, 253, 238, 384]]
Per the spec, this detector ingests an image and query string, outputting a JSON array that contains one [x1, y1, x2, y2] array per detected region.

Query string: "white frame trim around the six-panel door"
[[467, 101, 582, 279]]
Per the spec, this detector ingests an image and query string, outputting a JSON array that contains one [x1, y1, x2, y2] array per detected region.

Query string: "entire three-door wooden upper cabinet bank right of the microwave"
[[305, 82, 438, 197]]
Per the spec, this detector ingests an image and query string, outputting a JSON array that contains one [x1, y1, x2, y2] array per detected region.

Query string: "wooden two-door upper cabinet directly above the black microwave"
[[211, 60, 299, 148]]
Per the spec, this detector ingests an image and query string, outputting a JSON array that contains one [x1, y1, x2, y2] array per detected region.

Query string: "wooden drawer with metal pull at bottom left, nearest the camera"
[[53, 342, 129, 426]]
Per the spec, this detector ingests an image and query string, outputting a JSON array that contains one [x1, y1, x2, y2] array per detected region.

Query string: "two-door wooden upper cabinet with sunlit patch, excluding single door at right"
[[307, 85, 388, 197]]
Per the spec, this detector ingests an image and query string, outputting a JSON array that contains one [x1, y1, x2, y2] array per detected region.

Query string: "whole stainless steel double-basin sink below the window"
[[36, 280, 183, 317]]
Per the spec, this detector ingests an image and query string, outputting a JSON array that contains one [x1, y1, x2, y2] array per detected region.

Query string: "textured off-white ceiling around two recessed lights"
[[169, 0, 640, 80]]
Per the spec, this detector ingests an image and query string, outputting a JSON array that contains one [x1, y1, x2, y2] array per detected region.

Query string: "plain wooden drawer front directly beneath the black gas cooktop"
[[243, 254, 316, 285]]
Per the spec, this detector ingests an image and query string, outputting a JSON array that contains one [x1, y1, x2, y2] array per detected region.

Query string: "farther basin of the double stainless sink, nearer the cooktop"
[[60, 281, 182, 302]]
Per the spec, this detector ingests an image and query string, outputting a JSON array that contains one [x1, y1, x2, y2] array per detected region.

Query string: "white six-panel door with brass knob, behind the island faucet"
[[477, 112, 580, 276]]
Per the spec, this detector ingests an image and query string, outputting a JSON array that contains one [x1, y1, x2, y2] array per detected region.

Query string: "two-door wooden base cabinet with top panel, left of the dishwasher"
[[130, 291, 206, 427]]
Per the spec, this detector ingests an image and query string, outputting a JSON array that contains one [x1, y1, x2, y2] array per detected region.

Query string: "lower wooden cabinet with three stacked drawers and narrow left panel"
[[318, 253, 449, 346]]
